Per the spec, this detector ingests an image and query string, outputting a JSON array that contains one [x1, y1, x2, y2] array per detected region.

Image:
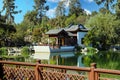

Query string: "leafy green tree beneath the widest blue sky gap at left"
[[11, 22, 31, 46]]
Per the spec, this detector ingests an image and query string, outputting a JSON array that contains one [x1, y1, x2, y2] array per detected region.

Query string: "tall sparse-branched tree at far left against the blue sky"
[[0, 0, 21, 24]]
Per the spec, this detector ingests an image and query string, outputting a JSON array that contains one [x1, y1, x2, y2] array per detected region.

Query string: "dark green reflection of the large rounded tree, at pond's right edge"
[[93, 51, 120, 69]]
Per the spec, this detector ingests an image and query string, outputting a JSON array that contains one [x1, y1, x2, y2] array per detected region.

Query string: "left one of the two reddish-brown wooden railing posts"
[[35, 60, 43, 80]]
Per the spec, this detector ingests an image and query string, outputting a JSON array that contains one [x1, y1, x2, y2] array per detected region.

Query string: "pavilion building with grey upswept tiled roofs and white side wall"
[[46, 24, 88, 47]]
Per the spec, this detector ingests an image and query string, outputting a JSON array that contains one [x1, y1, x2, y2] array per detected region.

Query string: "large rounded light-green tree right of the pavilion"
[[84, 13, 118, 50]]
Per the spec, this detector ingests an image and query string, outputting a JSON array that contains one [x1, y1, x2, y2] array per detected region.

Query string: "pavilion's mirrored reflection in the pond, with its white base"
[[32, 52, 84, 67]]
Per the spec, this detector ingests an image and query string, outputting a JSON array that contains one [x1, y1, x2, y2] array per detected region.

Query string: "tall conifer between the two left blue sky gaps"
[[33, 0, 49, 23]]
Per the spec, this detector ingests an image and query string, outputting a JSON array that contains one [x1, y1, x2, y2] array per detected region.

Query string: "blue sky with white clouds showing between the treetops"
[[0, 0, 101, 23]]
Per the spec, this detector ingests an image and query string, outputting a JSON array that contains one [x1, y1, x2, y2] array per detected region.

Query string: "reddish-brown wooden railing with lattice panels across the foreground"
[[0, 61, 120, 80]]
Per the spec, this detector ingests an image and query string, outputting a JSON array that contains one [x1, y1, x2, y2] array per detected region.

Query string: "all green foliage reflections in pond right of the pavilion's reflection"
[[83, 51, 120, 70]]
